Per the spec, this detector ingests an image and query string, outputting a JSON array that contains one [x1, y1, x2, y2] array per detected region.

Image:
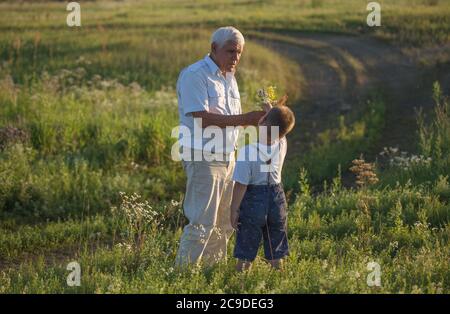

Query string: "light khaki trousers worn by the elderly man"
[[175, 153, 235, 266]]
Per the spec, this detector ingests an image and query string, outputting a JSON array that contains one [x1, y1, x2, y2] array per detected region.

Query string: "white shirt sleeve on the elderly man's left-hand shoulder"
[[180, 71, 209, 115]]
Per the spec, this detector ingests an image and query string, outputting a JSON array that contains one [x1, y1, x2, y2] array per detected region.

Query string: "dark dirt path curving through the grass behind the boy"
[[252, 33, 450, 159]]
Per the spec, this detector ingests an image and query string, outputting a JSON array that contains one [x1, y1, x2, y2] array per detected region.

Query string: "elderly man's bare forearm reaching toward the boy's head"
[[192, 111, 265, 128]]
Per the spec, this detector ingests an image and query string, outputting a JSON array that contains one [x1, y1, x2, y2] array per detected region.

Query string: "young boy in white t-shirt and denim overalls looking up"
[[230, 106, 295, 271]]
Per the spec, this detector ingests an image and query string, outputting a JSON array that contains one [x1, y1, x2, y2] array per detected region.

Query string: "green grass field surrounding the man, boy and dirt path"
[[0, 0, 450, 293]]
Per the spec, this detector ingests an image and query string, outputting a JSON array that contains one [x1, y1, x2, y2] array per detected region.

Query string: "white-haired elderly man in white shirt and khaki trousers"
[[176, 27, 264, 266]]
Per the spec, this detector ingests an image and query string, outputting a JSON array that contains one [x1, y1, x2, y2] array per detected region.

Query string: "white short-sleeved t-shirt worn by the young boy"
[[233, 137, 287, 185]]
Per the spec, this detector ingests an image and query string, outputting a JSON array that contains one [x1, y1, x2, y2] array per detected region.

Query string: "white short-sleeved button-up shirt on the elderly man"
[[177, 54, 242, 153]]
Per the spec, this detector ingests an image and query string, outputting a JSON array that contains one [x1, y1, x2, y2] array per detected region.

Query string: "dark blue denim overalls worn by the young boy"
[[234, 144, 289, 261]]
